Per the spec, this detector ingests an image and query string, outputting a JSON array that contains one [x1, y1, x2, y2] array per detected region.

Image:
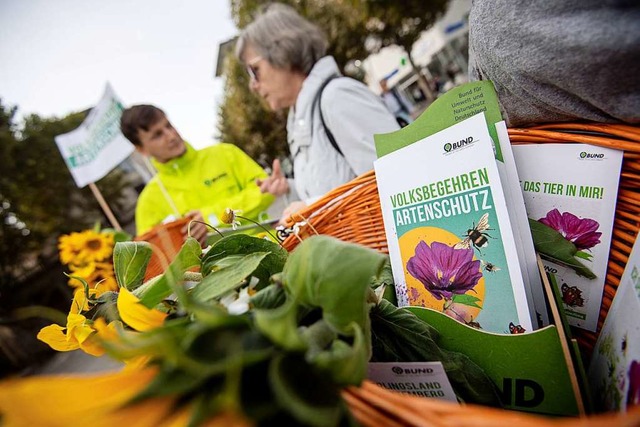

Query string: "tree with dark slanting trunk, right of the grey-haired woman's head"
[[360, 0, 449, 98]]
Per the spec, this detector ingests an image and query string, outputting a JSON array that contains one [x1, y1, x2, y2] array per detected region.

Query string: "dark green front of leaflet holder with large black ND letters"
[[406, 254, 588, 416]]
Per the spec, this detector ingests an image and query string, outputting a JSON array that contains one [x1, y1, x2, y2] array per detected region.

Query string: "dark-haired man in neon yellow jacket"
[[120, 105, 274, 243]]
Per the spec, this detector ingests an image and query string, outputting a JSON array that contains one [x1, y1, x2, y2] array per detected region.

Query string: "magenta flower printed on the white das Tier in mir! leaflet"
[[539, 209, 602, 250]]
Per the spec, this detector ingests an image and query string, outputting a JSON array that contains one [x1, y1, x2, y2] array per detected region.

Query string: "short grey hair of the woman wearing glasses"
[[236, 3, 328, 75]]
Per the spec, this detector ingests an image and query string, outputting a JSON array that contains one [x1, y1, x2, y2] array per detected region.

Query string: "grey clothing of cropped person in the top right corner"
[[469, 0, 640, 127]]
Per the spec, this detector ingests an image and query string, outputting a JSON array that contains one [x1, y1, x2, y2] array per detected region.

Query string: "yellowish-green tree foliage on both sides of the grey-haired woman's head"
[[218, 0, 449, 165]]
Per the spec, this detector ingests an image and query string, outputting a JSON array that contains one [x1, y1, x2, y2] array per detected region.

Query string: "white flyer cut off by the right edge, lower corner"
[[589, 232, 640, 412]]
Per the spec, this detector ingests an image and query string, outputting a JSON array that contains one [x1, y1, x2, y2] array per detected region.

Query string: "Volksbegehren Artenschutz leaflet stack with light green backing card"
[[374, 82, 549, 333]]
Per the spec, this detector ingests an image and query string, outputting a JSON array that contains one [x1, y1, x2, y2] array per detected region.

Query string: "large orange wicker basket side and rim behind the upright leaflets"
[[283, 123, 640, 358]]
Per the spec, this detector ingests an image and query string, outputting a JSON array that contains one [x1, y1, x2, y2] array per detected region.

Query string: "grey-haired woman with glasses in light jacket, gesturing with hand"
[[236, 4, 399, 220]]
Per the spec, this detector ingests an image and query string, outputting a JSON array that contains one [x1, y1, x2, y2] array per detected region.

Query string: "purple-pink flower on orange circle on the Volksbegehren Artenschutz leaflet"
[[407, 242, 482, 300]]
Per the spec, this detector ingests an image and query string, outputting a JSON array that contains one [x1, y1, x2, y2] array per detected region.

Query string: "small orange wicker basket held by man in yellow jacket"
[[134, 218, 191, 282]]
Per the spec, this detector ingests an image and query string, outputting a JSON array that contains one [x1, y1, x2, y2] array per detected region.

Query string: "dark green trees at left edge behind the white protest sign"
[[0, 101, 131, 284]]
